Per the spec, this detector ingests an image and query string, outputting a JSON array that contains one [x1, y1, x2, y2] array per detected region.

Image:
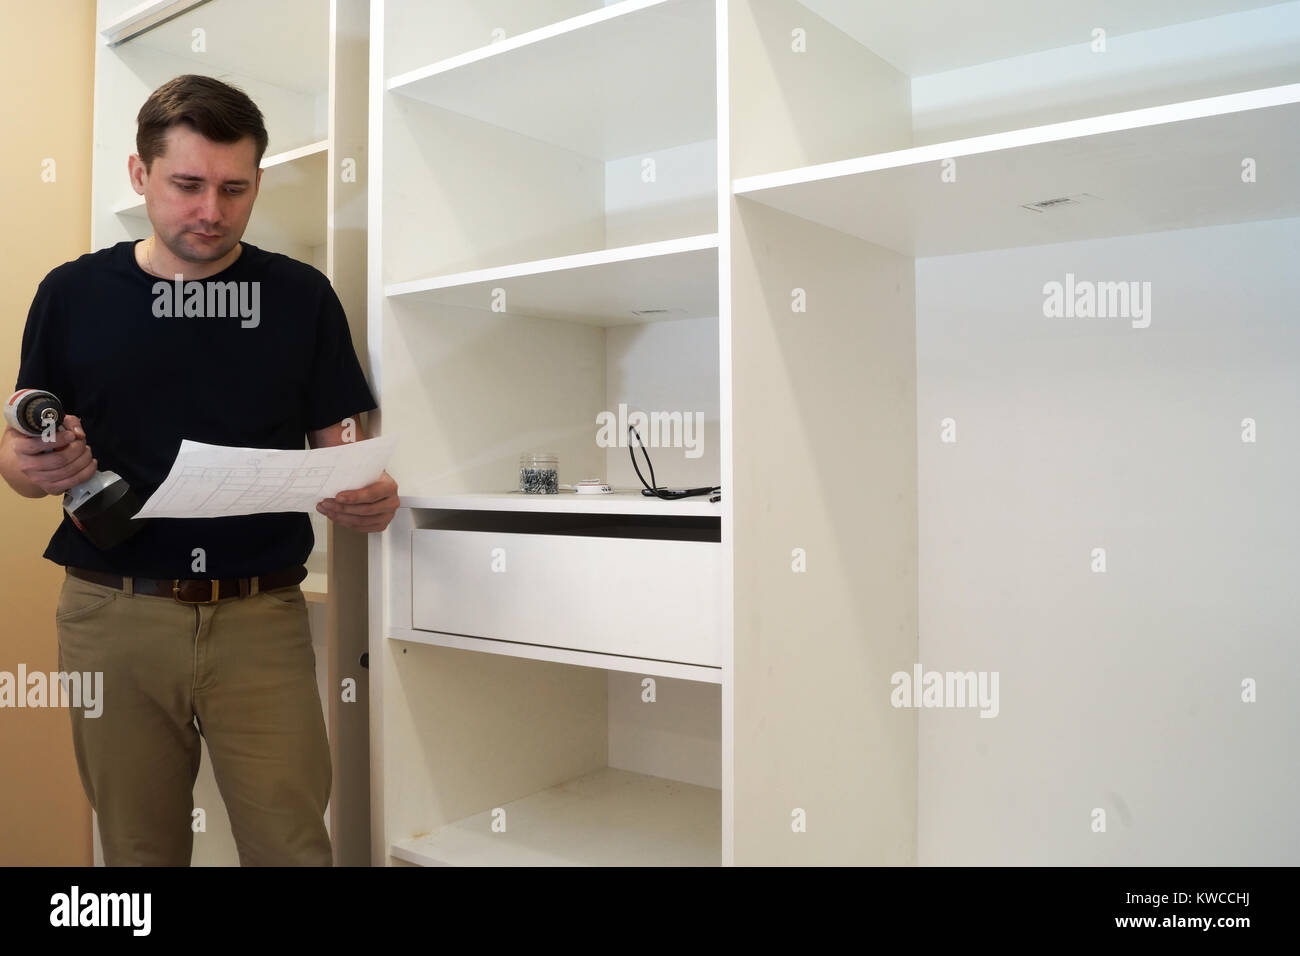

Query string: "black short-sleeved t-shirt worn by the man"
[[14, 241, 377, 578]]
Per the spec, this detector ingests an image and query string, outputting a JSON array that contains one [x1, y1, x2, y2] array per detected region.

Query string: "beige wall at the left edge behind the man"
[[0, 0, 95, 865]]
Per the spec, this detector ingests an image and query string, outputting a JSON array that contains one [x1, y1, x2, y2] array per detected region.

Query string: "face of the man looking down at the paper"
[[130, 125, 261, 263]]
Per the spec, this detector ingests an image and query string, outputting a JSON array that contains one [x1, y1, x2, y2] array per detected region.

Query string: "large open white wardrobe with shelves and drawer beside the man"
[[368, 0, 1300, 865]]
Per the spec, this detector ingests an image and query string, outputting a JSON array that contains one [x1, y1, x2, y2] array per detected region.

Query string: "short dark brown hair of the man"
[[135, 73, 268, 169]]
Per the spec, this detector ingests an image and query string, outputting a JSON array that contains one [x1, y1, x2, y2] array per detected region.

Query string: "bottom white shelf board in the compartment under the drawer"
[[390, 767, 722, 866]]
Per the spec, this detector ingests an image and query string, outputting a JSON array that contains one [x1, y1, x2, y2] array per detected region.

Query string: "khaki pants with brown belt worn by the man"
[[55, 575, 332, 866]]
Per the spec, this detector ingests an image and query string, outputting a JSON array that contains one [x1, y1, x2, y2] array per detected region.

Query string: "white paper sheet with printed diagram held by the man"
[[135, 436, 397, 518]]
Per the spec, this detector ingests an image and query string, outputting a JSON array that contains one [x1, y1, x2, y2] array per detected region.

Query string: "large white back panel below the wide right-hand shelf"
[[917, 220, 1300, 865]]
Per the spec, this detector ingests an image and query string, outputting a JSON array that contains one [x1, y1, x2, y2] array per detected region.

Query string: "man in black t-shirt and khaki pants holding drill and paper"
[[0, 75, 398, 866]]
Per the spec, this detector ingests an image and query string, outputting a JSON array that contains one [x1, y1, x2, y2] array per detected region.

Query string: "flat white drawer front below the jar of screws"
[[411, 528, 722, 667]]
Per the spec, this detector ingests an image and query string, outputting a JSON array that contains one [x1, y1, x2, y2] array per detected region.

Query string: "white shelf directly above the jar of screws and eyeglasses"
[[384, 233, 718, 326]]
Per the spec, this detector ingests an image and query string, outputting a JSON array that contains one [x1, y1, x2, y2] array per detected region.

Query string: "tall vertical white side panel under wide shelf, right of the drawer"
[[732, 199, 917, 865]]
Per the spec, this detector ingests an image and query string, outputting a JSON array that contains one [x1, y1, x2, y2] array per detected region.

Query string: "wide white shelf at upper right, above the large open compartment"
[[733, 83, 1300, 256]]
